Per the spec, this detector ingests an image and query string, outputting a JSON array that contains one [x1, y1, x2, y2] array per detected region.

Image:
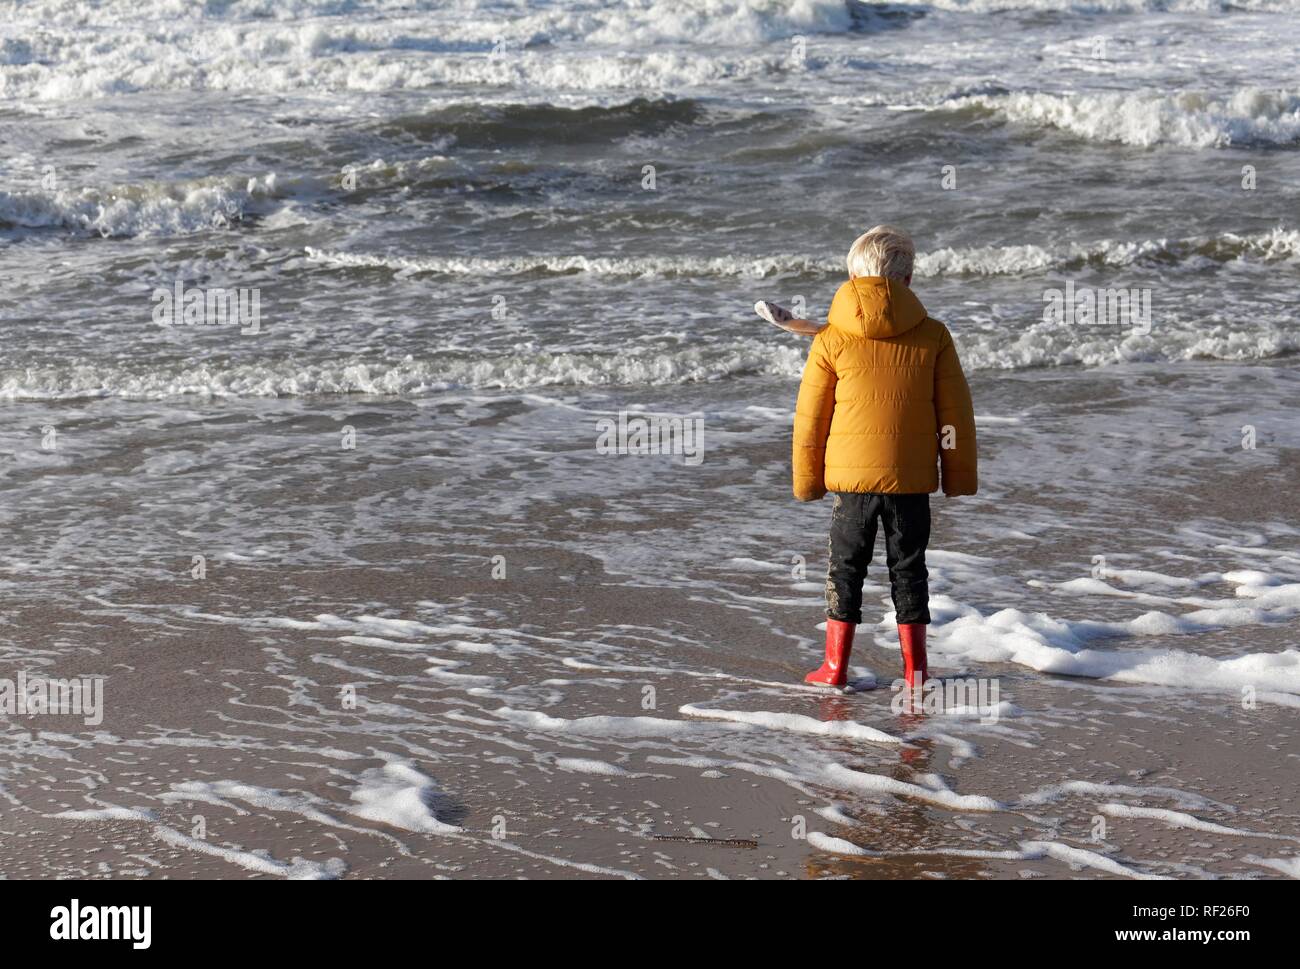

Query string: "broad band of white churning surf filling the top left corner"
[[0, 0, 863, 100]]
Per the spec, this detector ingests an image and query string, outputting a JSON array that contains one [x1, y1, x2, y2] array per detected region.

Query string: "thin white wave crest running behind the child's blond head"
[[306, 228, 1300, 280]]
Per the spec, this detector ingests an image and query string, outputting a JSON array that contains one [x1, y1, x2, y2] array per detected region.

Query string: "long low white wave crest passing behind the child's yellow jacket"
[[0, 325, 1300, 401]]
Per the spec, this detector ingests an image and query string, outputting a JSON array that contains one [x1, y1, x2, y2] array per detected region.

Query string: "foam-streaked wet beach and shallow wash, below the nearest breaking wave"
[[3, 364, 1300, 878]]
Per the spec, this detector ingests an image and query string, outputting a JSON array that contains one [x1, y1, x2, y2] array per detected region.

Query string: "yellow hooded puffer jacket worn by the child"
[[794, 276, 978, 501]]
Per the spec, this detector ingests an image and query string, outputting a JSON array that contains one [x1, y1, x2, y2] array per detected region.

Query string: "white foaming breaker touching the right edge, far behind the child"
[[928, 87, 1300, 148]]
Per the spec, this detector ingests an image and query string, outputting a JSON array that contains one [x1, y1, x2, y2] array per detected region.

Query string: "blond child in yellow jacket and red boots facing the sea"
[[772, 225, 978, 688]]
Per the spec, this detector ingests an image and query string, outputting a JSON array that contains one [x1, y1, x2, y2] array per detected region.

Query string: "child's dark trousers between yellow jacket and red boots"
[[826, 492, 930, 623]]
